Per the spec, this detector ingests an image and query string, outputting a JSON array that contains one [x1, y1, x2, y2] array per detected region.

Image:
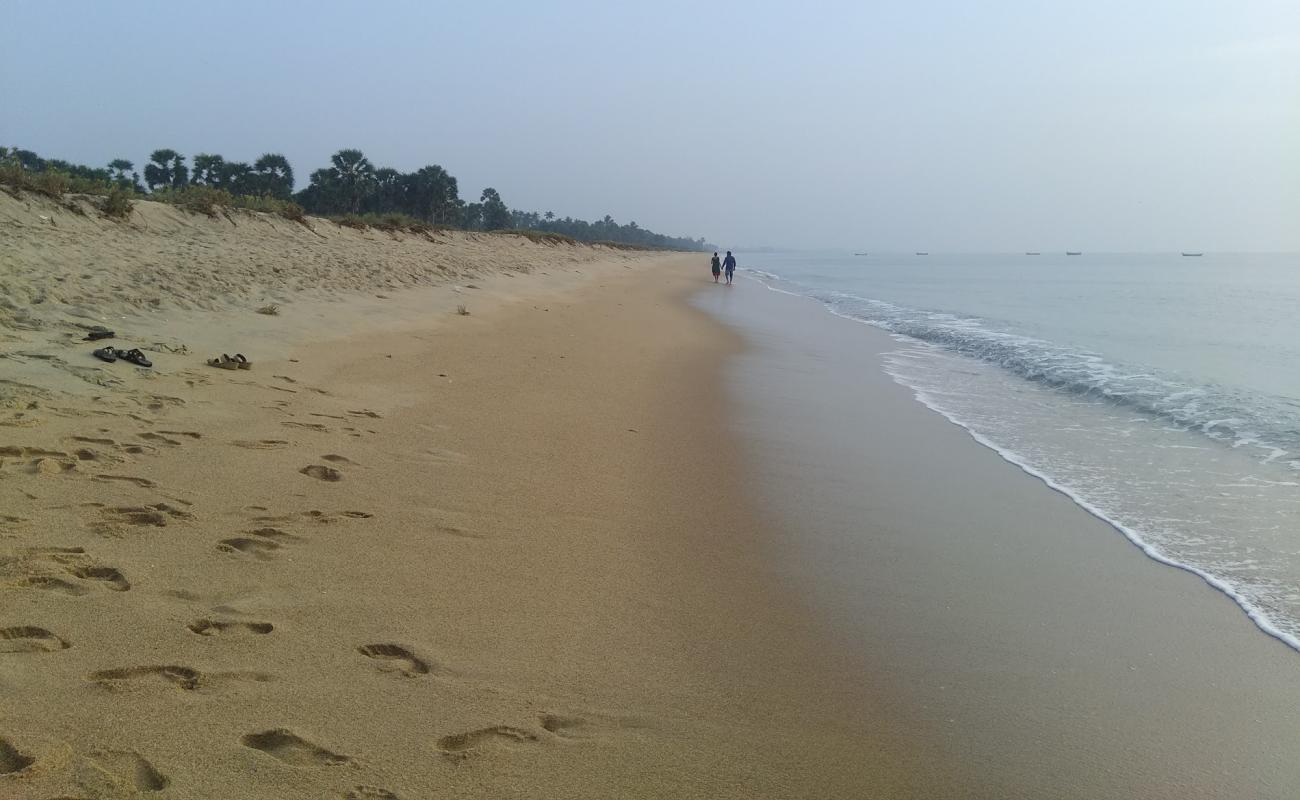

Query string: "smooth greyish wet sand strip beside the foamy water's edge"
[[696, 280, 1300, 799]]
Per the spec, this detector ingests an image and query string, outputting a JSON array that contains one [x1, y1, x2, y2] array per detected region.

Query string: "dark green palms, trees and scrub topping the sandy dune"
[[0, 147, 715, 250]]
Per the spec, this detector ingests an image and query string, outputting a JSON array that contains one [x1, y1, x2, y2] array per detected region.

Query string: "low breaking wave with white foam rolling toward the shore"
[[749, 269, 1300, 470]]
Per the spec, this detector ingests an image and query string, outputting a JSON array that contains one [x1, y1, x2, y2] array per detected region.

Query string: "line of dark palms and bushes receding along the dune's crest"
[[0, 147, 715, 250]]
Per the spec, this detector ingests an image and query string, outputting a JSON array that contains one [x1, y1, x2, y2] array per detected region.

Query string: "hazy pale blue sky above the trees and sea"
[[0, 0, 1300, 252]]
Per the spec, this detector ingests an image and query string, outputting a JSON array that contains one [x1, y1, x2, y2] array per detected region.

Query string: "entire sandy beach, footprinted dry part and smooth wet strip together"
[[0, 191, 1300, 800]]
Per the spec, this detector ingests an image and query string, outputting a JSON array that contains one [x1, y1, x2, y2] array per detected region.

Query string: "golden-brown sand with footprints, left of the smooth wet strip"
[[0, 195, 894, 800]]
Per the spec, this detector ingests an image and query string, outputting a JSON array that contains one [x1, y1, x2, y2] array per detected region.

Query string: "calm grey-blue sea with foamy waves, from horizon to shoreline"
[[740, 252, 1300, 650]]
